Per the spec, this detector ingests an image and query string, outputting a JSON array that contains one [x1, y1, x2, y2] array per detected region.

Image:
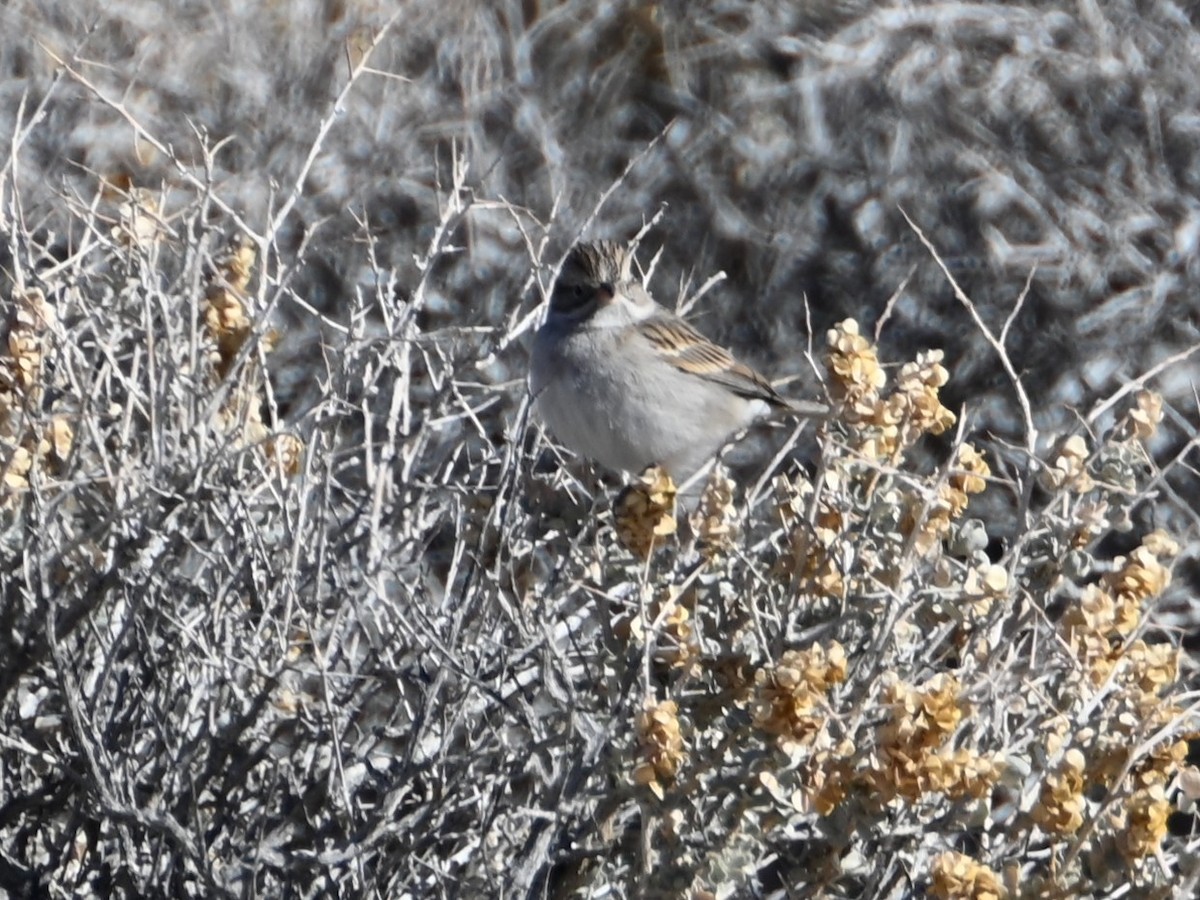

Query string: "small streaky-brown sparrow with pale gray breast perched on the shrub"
[[529, 241, 828, 482]]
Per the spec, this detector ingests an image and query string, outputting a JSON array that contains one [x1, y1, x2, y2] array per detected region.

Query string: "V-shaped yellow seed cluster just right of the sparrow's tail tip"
[[826, 319, 955, 460]]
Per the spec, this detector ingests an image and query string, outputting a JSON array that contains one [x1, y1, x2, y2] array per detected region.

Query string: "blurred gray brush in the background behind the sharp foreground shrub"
[[9, 1, 1200, 428]]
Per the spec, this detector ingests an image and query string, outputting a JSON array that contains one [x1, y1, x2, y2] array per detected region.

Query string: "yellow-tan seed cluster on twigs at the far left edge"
[[0, 288, 74, 506]]
